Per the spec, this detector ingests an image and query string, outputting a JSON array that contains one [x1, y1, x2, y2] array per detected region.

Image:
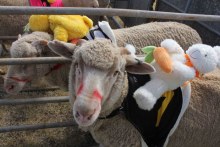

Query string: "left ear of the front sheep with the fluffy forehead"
[[47, 40, 76, 59]]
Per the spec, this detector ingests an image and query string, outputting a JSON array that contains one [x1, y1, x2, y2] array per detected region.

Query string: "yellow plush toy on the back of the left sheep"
[[29, 15, 93, 42]]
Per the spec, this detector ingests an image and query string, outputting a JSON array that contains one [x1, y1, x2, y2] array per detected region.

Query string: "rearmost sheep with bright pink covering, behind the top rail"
[[0, 0, 104, 36]]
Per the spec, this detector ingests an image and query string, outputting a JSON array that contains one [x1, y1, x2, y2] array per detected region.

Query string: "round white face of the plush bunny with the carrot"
[[186, 44, 219, 74]]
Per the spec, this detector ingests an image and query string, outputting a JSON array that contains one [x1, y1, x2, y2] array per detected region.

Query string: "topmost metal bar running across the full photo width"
[[0, 6, 220, 21]]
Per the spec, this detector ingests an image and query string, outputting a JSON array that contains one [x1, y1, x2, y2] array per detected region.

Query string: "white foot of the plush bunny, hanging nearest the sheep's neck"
[[134, 88, 157, 110]]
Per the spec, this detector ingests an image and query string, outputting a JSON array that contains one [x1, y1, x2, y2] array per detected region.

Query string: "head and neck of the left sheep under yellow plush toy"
[[4, 32, 69, 94]]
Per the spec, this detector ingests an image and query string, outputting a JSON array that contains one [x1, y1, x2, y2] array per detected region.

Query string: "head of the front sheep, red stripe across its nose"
[[48, 39, 154, 126]]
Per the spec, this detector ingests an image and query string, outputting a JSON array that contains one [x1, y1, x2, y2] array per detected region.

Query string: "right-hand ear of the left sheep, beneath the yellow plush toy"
[[31, 40, 49, 55]]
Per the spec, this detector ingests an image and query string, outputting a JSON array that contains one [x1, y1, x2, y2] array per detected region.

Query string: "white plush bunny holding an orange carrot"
[[134, 39, 220, 110]]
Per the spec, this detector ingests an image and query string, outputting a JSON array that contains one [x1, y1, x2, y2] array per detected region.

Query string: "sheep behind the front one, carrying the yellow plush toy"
[[4, 22, 201, 93]]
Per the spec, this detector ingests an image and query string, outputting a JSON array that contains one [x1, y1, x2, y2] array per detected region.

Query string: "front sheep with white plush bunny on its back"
[[48, 37, 220, 147]]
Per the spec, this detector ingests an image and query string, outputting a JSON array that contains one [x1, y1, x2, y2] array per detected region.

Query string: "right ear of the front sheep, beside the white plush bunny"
[[125, 56, 156, 74]]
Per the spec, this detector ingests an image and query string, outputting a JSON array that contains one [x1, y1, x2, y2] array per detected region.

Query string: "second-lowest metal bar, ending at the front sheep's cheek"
[[0, 96, 69, 106]]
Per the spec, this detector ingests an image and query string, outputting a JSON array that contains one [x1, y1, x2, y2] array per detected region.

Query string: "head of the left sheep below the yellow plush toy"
[[4, 32, 50, 94]]
